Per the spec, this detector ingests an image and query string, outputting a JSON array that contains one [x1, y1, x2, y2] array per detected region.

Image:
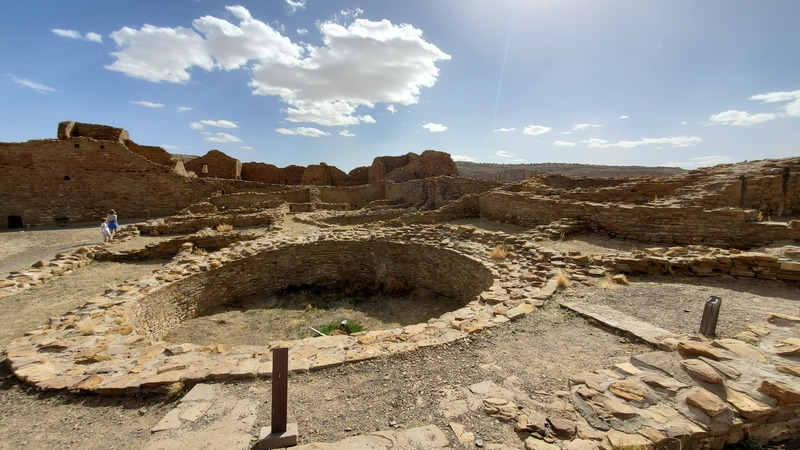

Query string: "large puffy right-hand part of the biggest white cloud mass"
[[250, 19, 450, 125]]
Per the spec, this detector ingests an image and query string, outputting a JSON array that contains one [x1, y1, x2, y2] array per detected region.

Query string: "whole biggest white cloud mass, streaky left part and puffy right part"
[[106, 7, 451, 126]]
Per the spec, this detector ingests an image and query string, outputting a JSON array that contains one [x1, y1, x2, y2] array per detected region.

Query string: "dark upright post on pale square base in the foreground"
[[256, 348, 297, 450]]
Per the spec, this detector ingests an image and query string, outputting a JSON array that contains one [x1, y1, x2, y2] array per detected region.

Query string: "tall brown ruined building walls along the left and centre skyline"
[[0, 122, 456, 228]]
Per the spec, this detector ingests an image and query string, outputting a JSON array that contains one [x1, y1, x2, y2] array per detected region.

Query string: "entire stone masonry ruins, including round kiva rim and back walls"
[[0, 122, 800, 449]]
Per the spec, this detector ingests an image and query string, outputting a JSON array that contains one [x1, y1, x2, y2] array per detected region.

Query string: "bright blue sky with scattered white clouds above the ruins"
[[0, 0, 800, 171]]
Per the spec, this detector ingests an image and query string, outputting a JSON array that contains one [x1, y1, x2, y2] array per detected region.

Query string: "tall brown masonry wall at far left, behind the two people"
[[0, 138, 213, 228]]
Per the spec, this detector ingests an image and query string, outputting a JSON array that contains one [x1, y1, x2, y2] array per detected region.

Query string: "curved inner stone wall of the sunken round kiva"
[[129, 240, 493, 340]]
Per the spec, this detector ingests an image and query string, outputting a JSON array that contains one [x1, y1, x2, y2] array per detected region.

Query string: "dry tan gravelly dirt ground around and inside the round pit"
[[0, 221, 800, 449]]
